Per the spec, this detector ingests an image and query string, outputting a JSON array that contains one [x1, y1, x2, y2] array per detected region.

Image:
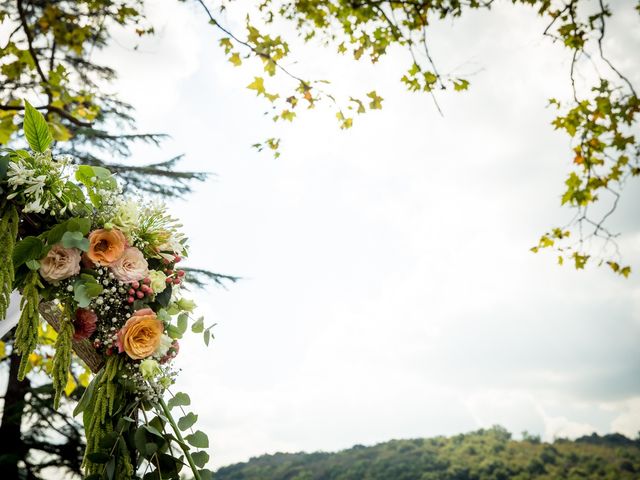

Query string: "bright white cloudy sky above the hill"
[[89, 1, 640, 468]]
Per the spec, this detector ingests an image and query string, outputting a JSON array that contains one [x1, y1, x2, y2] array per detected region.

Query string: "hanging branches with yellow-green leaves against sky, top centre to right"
[[196, 0, 640, 277]]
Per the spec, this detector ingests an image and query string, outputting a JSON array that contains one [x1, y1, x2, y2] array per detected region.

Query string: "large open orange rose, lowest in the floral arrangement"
[[118, 308, 164, 360]]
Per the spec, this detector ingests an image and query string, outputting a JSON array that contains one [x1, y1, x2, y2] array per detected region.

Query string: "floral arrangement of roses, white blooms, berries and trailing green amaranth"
[[0, 102, 211, 480]]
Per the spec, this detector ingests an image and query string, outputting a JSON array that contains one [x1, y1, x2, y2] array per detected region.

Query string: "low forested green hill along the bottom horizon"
[[215, 427, 640, 480]]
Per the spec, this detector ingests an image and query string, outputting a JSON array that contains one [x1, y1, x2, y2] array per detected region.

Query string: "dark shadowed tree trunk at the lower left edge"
[[0, 354, 30, 479]]
